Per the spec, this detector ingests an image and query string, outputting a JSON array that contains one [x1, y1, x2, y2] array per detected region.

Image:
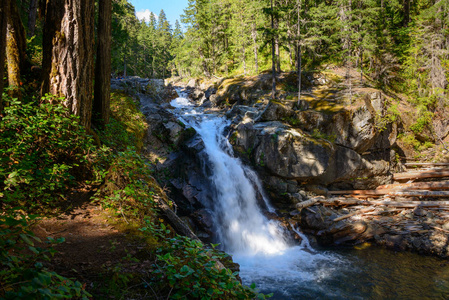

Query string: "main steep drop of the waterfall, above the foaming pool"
[[194, 117, 288, 255]]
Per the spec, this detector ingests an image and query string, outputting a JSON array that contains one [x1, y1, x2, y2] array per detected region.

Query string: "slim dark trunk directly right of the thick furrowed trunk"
[[93, 0, 112, 124]]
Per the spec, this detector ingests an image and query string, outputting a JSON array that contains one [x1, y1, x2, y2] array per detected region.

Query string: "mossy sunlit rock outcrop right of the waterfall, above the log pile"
[[169, 73, 397, 202]]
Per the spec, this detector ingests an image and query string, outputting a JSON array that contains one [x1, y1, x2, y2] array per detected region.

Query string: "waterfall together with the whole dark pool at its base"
[[166, 92, 449, 299]]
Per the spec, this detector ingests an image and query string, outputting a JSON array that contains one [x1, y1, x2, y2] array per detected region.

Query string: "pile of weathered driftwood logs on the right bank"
[[297, 163, 449, 235]]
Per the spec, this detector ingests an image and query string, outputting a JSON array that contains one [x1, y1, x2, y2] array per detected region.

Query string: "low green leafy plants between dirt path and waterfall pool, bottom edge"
[[141, 219, 270, 299]]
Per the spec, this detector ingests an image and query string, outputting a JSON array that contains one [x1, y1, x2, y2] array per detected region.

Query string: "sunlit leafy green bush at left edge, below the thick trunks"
[[0, 96, 107, 208]]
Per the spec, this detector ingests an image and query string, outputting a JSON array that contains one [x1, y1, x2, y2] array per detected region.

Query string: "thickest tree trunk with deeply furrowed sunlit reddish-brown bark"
[[48, 0, 94, 129]]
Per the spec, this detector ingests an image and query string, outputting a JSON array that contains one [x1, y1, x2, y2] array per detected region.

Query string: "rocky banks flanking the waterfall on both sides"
[[119, 73, 449, 257]]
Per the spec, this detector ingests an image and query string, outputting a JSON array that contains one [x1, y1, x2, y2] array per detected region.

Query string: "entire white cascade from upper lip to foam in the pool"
[[171, 91, 338, 299]]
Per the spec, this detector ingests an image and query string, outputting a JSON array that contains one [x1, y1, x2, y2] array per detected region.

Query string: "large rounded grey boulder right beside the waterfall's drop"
[[231, 121, 390, 189]]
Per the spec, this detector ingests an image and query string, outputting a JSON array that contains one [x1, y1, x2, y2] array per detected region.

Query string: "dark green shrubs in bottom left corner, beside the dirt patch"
[[0, 211, 91, 299]]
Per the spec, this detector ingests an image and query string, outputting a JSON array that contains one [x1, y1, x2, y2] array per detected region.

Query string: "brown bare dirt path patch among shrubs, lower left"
[[33, 190, 154, 299]]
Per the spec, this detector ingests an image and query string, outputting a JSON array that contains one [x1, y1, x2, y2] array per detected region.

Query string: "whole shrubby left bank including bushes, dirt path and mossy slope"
[[0, 92, 266, 299]]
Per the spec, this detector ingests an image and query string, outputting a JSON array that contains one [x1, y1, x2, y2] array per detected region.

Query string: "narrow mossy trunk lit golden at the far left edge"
[[6, 1, 26, 98]]
